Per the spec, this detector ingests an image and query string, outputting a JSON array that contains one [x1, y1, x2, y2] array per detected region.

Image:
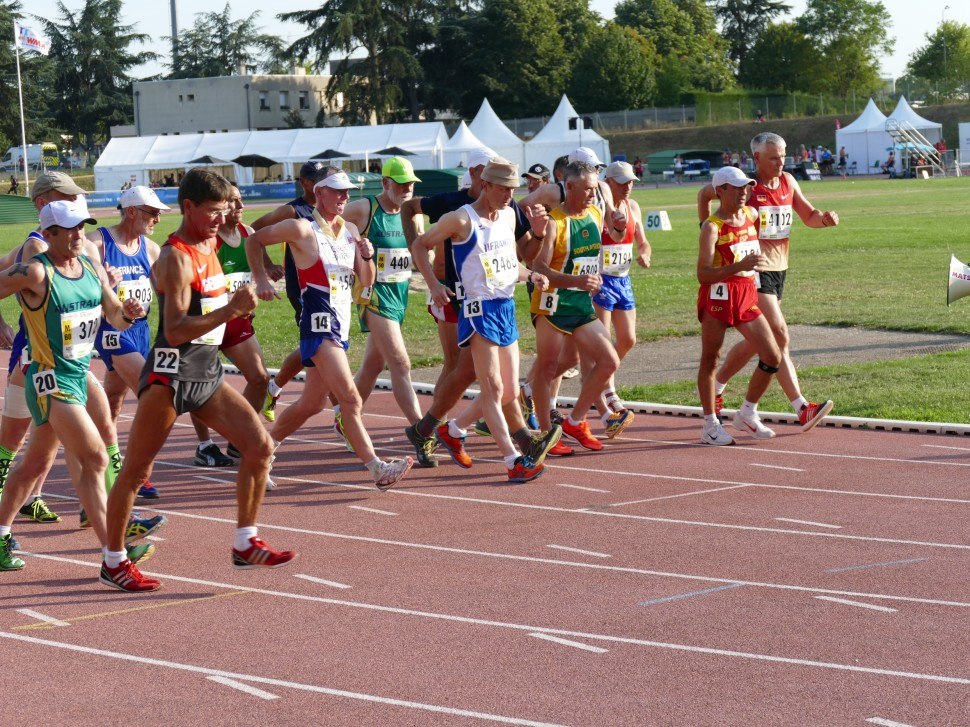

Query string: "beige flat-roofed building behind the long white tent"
[[133, 68, 343, 136]]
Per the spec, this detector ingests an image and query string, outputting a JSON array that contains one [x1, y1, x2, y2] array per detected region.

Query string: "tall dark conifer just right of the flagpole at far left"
[[41, 0, 156, 149]]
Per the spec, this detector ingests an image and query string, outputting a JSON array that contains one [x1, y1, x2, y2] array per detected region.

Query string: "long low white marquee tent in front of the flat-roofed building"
[[94, 121, 448, 191]]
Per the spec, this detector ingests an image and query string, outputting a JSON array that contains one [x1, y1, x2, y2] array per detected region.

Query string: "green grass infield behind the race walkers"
[[0, 178, 970, 423]]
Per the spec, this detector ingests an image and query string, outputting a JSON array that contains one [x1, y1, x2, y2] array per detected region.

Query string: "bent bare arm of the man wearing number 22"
[[155, 247, 257, 346]]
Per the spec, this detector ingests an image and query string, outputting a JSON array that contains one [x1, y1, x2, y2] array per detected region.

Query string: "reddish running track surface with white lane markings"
[[0, 366, 970, 726]]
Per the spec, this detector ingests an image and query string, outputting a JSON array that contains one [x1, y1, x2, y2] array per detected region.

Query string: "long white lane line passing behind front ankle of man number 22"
[[45, 494, 970, 608]]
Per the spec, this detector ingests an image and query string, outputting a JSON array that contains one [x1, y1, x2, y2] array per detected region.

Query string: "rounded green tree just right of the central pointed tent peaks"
[[569, 23, 657, 111]]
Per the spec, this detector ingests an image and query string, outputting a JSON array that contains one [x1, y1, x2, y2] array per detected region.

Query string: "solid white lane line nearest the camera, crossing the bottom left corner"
[[0, 631, 559, 727]]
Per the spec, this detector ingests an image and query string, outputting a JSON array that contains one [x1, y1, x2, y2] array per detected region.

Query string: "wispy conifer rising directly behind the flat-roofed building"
[[169, 3, 286, 78]]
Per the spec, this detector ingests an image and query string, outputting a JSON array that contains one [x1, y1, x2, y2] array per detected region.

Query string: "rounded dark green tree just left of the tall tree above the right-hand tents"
[[738, 23, 823, 93]]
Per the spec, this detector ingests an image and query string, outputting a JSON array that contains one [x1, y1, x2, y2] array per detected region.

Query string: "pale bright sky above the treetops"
[[23, 0, 970, 83]]
